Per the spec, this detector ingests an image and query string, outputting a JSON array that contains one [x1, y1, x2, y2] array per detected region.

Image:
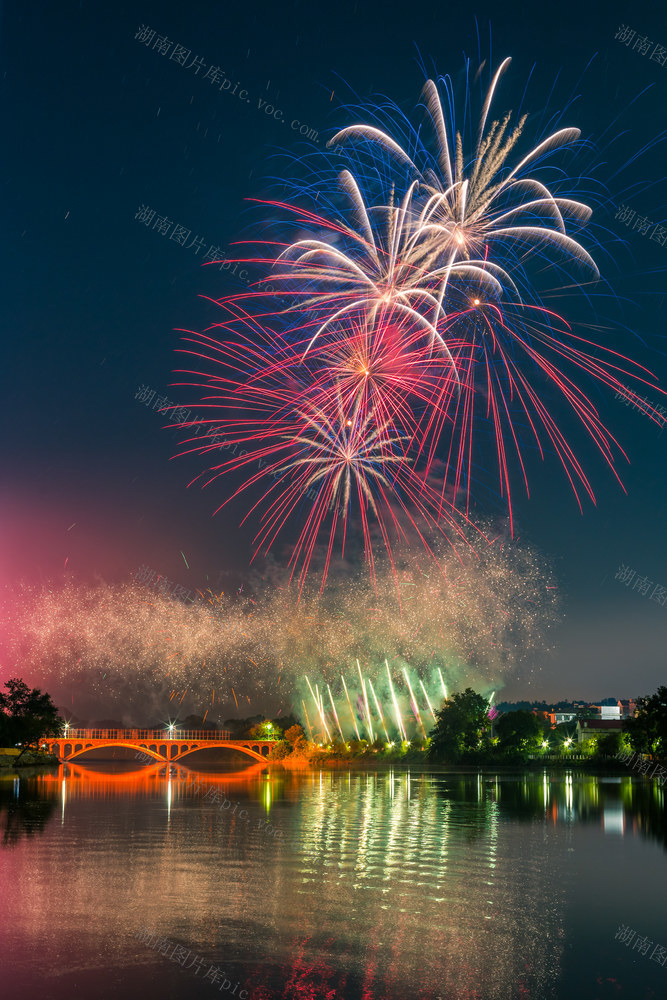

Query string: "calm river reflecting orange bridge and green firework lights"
[[0, 762, 667, 1000]]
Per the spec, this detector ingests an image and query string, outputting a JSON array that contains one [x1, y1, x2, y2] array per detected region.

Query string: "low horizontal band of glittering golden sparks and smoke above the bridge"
[[2, 528, 558, 720]]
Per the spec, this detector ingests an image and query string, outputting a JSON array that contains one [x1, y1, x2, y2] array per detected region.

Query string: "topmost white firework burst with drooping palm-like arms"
[[329, 59, 598, 284]]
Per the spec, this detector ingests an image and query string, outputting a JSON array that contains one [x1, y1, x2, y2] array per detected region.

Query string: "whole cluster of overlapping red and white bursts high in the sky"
[[171, 60, 660, 587]]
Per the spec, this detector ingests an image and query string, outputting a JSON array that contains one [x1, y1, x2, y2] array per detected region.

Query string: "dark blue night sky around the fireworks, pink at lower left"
[[0, 0, 667, 699]]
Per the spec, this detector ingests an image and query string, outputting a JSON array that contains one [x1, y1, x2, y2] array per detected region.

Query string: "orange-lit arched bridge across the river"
[[42, 728, 276, 764]]
